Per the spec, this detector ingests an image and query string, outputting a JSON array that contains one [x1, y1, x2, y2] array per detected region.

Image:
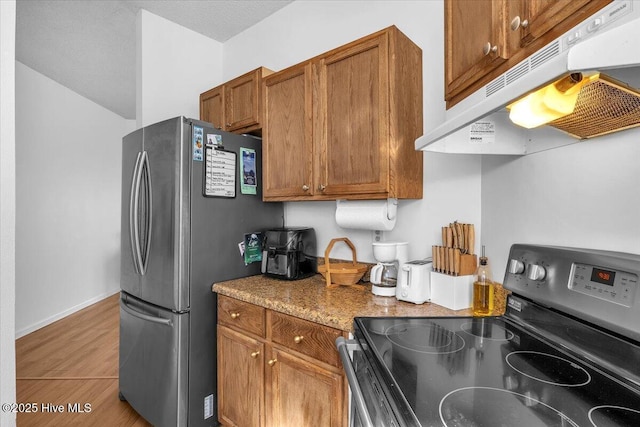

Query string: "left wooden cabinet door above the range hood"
[[445, 0, 519, 100]]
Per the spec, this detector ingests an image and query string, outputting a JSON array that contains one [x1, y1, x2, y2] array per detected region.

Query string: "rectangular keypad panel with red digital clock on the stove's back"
[[569, 263, 638, 307]]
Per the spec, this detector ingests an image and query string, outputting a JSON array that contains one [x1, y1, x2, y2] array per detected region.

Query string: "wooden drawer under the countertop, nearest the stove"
[[270, 311, 342, 366]]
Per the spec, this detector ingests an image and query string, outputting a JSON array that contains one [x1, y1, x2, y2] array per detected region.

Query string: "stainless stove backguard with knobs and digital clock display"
[[503, 244, 640, 342]]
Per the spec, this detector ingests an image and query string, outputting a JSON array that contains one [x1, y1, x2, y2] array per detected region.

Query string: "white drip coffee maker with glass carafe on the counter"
[[369, 242, 409, 297]]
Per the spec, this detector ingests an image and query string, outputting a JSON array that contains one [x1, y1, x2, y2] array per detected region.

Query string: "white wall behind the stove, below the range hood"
[[482, 130, 640, 281]]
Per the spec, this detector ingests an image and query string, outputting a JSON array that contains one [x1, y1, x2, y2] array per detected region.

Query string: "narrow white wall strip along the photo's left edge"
[[0, 0, 16, 427]]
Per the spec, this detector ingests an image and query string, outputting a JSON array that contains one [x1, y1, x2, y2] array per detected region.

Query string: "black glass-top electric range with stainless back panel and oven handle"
[[337, 245, 640, 427]]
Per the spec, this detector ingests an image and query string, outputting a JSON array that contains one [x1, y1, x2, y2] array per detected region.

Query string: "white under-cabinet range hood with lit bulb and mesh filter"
[[415, 0, 640, 155]]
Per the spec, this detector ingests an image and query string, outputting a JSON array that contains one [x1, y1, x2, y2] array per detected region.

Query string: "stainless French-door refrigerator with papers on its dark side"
[[119, 117, 283, 427]]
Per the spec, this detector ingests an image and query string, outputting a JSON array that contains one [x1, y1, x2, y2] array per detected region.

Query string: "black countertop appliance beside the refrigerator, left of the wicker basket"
[[262, 227, 318, 280]]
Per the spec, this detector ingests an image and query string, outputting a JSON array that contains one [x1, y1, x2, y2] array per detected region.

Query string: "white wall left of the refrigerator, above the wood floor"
[[15, 62, 132, 337]]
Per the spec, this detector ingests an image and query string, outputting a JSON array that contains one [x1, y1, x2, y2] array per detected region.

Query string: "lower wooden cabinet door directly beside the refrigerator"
[[218, 326, 264, 426]]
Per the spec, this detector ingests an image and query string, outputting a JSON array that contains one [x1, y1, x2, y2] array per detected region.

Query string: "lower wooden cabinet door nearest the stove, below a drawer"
[[266, 349, 347, 427]]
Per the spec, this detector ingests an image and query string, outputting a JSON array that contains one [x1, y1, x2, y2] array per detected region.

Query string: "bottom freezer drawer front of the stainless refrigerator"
[[119, 293, 189, 427]]
